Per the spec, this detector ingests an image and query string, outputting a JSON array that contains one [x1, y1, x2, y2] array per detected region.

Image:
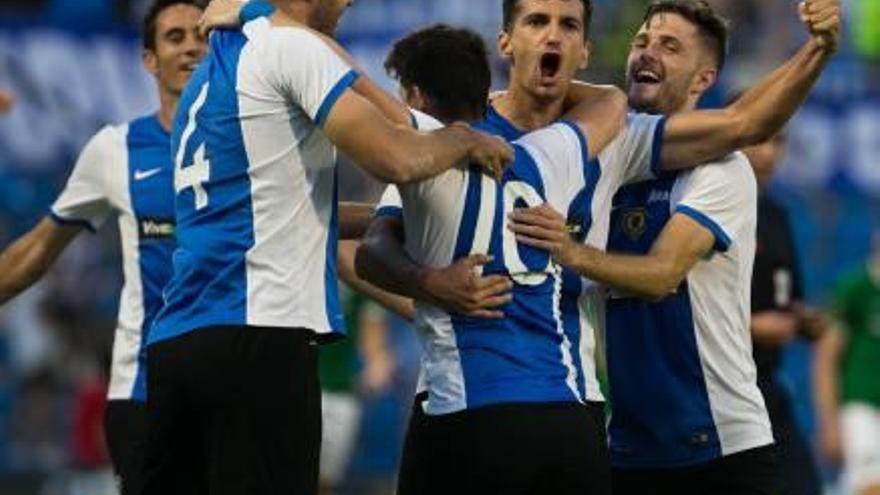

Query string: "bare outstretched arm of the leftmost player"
[[0, 218, 82, 305]]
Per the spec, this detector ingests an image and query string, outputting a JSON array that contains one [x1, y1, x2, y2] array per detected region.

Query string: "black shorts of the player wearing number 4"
[[144, 327, 321, 495]]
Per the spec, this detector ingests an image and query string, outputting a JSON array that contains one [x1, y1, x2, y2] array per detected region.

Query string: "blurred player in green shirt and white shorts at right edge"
[[815, 232, 880, 495]]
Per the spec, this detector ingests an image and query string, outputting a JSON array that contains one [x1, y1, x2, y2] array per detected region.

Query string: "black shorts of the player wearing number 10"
[[397, 400, 611, 495]]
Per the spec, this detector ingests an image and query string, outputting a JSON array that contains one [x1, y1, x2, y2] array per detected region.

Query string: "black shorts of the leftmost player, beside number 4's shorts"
[[104, 400, 147, 495]]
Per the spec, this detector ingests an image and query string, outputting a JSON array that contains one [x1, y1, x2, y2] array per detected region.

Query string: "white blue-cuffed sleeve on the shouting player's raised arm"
[[614, 113, 666, 185]]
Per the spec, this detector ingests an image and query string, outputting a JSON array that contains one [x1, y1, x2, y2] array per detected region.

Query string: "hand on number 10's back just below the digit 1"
[[420, 254, 513, 319]]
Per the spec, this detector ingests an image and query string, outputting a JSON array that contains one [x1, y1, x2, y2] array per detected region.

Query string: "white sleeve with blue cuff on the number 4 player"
[[264, 27, 358, 126]]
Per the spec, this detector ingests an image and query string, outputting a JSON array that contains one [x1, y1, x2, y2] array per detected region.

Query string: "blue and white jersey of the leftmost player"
[[51, 115, 176, 401]]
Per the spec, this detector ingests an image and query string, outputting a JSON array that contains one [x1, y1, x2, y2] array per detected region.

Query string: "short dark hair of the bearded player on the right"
[[644, 0, 730, 72]]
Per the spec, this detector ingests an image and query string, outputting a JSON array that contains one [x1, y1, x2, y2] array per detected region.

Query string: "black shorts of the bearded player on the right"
[[613, 446, 781, 495]]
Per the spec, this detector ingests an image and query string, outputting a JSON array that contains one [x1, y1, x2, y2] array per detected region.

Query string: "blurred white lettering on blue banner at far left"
[[0, 28, 157, 168]]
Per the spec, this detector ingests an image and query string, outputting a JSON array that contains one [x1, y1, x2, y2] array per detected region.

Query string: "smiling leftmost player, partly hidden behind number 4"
[[0, 0, 207, 495]]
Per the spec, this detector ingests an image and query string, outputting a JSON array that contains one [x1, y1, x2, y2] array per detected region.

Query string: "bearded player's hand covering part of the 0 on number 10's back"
[[508, 204, 578, 266]]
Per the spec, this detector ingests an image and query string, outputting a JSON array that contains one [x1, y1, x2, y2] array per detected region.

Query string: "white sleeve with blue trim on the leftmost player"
[[50, 127, 121, 231]]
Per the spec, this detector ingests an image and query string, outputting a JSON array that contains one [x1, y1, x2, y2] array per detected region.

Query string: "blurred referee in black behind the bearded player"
[[743, 134, 828, 495]]
